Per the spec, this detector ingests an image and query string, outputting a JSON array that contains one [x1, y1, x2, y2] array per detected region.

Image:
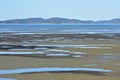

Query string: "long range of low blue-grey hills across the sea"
[[0, 17, 120, 24]]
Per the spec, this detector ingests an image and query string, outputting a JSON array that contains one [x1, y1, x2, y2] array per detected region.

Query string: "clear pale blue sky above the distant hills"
[[0, 0, 120, 20]]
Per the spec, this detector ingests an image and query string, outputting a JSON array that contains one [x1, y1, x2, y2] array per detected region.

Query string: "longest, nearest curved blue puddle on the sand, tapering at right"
[[0, 67, 112, 74]]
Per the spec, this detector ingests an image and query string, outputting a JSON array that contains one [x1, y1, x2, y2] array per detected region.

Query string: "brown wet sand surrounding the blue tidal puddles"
[[0, 35, 120, 80]]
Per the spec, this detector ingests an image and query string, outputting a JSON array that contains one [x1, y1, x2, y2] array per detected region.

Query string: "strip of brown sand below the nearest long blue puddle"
[[3, 73, 120, 80]]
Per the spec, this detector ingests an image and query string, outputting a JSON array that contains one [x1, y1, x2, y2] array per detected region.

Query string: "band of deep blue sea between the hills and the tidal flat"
[[0, 24, 120, 34]]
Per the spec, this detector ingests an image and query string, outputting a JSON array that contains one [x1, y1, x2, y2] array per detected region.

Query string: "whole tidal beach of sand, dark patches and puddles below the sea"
[[0, 33, 120, 80]]
